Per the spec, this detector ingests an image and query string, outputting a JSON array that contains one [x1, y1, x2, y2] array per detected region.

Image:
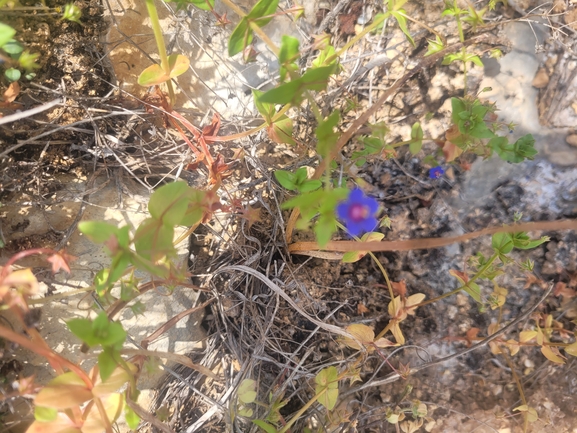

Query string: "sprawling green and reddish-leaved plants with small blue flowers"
[[0, 0, 577, 433]]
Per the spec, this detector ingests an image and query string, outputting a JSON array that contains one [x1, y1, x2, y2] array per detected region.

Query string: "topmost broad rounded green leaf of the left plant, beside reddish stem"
[[148, 181, 191, 226]]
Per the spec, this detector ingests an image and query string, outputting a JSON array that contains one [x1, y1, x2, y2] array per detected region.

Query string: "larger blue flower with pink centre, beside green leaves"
[[337, 188, 379, 236]]
